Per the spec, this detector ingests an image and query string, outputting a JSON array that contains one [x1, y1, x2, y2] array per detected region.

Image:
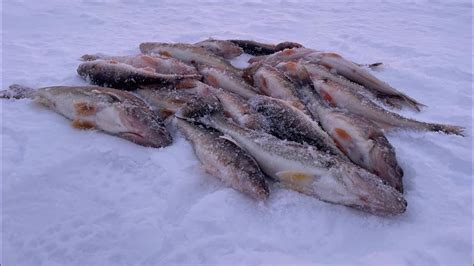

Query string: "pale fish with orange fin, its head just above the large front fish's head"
[[301, 87, 403, 193]]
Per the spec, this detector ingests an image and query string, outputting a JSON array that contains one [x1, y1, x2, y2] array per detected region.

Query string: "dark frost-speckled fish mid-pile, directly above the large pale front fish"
[[249, 95, 347, 159]]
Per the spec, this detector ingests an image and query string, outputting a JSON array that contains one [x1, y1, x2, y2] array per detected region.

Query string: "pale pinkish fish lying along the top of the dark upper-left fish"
[[81, 54, 199, 76]]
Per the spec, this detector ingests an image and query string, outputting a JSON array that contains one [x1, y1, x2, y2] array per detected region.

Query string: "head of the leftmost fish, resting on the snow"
[[116, 104, 172, 148]]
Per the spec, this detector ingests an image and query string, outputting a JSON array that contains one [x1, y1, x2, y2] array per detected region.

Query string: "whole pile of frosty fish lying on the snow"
[[0, 39, 463, 215]]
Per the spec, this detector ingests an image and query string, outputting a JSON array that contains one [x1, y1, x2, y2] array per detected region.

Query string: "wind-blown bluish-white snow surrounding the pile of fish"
[[1, 0, 472, 265]]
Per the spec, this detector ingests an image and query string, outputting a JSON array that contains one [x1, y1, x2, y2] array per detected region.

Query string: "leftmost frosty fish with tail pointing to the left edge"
[[0, 85, 172, 148]]
